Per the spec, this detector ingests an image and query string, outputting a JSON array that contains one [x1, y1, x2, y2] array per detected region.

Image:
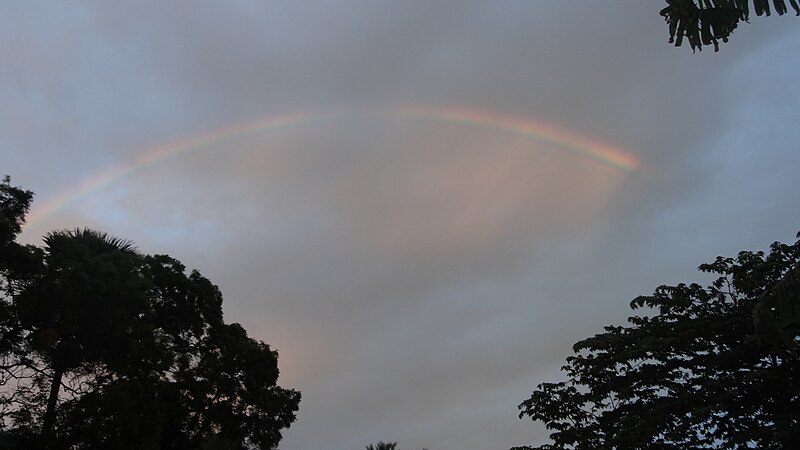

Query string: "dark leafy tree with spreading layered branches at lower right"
[[519, 235, 800, 450]]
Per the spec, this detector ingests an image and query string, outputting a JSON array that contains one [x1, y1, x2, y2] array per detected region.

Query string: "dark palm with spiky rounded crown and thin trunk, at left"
[[14, 230, 146, 440]]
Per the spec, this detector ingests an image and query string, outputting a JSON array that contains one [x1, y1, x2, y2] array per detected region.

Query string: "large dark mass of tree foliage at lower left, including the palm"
[[0, 178, 300, 449]]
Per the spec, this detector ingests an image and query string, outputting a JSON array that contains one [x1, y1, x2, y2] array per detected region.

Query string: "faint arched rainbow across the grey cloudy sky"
[[21, 107, 641, 228]]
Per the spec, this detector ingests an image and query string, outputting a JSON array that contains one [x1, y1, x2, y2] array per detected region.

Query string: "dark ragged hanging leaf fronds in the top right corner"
[[661, 0, 800, 51]]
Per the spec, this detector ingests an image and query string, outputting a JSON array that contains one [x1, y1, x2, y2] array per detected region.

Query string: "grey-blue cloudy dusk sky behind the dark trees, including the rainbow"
[[0, 0, 800, 450]]
